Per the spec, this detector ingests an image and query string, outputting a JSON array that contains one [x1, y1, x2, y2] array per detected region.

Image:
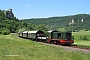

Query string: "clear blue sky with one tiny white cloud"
[[0, 0, 90, 19]]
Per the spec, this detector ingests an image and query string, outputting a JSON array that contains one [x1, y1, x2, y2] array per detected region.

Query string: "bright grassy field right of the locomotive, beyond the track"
[[73, 31, 90, 48]]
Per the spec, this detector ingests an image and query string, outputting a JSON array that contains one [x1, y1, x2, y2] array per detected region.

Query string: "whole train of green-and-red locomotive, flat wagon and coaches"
[[18, 30, 74, 45]]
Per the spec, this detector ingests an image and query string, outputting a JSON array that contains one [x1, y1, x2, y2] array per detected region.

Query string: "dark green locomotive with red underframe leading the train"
[[48, 31, 74, 44]]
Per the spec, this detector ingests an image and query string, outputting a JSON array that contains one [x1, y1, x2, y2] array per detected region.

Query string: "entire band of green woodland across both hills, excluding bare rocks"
[[0, 10, 90, 35]]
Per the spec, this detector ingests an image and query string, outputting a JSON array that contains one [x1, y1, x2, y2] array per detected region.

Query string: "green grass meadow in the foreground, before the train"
[[0, 35, 90, 60]]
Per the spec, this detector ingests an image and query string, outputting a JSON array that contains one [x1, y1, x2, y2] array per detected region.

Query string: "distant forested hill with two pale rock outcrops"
[[23, 14, 90, 31]]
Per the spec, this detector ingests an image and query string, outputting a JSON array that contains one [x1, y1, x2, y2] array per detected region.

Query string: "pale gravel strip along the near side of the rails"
[[39, 42, 90, 54]]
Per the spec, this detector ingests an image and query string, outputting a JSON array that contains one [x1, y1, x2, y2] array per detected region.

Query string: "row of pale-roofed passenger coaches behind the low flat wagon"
[[18, 30, 44, 40]]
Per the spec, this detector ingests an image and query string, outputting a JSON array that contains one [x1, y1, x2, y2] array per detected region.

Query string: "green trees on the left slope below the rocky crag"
[[0, 10, 32, 34]]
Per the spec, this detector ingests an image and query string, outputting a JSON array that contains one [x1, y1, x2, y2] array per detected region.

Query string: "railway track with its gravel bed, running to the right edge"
[[38, 42, 90, 54]]
